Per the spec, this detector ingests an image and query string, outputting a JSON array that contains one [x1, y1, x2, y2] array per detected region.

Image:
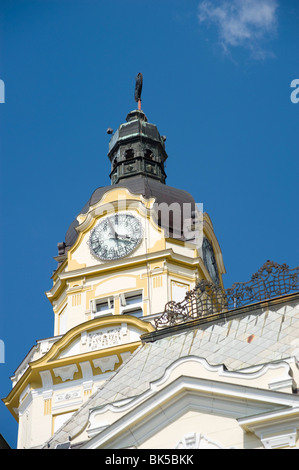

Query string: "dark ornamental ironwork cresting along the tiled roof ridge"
[[155, 261, 299, 328]]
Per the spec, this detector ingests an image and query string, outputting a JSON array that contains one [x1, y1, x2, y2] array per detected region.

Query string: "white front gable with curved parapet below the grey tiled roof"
[[83, 357, 299, 449]]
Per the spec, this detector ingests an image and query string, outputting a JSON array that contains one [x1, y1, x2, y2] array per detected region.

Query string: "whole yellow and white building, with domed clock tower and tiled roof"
[[4, 85, 299, 449]]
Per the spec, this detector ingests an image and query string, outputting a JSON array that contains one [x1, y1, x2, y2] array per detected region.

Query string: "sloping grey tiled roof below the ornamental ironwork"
[[45, 294, 299, 448]]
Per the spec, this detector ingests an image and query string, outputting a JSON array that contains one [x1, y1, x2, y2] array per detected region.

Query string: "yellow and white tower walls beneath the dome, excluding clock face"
[[5, 179, 224, 448]]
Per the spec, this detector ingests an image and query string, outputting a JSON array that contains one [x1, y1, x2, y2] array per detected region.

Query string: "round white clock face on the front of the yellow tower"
[[89, 213, 142, 261]]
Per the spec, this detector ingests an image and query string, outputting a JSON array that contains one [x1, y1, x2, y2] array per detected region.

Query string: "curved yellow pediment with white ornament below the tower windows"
[[6, 315, 154, 417]]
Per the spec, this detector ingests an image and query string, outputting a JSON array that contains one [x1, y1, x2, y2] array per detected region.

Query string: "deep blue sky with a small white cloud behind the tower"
[[0, 0, 299, 447]]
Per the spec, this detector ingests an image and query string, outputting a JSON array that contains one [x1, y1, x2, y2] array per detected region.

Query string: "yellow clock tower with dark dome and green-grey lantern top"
[[4, 79, 225, 448]]
